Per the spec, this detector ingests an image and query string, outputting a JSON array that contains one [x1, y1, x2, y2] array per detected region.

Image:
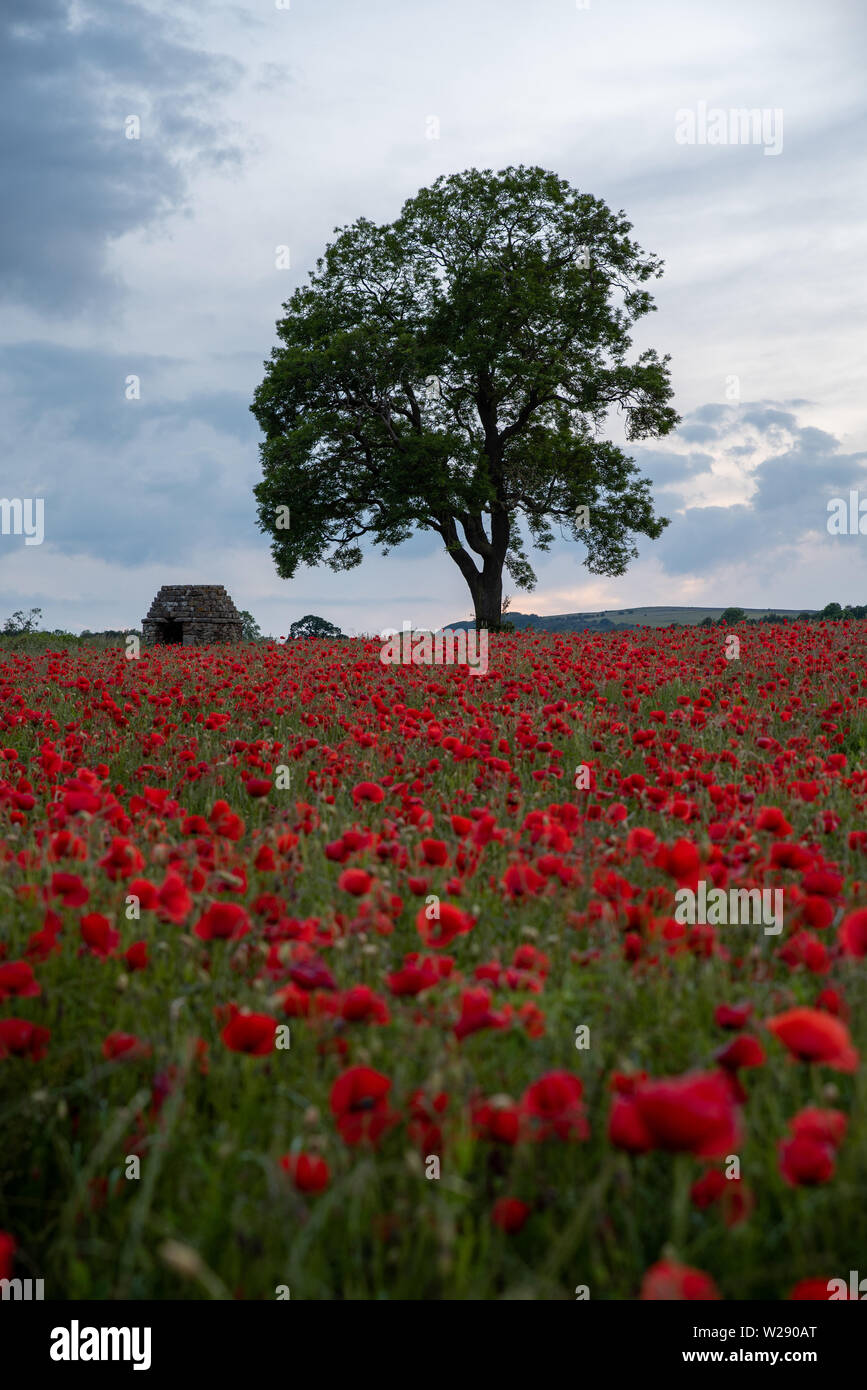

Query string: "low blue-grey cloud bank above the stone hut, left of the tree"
[[0, 343, 261, 566]]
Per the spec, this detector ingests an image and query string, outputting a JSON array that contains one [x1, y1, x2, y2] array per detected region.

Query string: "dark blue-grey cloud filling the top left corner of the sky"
[[0, 0, 240, 316]]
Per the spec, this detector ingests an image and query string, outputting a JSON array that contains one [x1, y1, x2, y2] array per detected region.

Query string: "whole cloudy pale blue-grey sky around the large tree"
[[0, 0, 867, 637]]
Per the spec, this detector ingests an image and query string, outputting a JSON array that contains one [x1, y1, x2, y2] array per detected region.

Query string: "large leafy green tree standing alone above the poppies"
[[251, 165, 678, 627]]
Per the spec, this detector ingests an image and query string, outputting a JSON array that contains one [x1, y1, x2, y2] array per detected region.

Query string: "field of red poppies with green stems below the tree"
[[0, 623, 867, 1300]]
